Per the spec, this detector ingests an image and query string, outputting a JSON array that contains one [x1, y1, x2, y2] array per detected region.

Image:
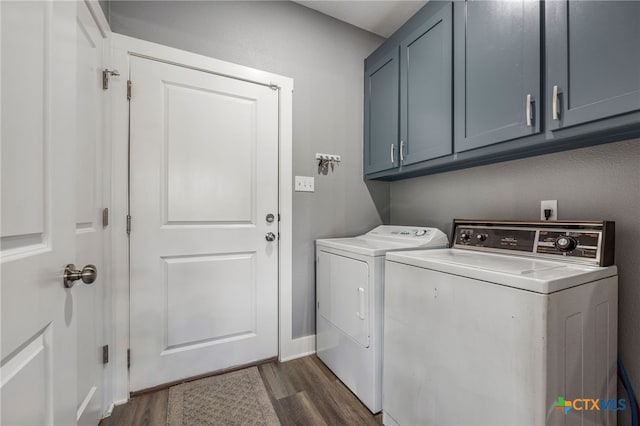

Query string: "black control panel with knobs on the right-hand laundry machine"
[[452, 219, 615, 266]]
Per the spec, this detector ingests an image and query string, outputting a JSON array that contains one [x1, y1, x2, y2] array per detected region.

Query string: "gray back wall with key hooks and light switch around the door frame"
[[109, 1, 389, 337]]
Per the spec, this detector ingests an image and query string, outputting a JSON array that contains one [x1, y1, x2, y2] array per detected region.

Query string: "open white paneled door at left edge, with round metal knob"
[[0, 1, 79, 425]]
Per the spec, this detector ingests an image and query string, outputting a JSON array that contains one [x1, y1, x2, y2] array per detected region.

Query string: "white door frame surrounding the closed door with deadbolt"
[[107, 33, 298, 405]]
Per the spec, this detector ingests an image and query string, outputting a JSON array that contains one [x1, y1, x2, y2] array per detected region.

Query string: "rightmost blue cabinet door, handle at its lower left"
[[545, 0, 640, 129]]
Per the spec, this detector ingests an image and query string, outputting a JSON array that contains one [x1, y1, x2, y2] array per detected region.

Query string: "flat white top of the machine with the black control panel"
[[387, 249, 618, 294]]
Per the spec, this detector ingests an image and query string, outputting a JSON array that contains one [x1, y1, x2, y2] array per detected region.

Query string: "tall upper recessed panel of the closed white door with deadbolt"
[[165, 83, 256, 223]]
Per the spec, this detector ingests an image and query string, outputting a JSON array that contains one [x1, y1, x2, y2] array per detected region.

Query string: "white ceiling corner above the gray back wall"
[[293, 0, 427, 38]]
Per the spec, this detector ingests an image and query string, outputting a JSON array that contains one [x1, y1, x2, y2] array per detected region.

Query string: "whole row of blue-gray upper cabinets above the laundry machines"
[[364, 0, 640, 180]]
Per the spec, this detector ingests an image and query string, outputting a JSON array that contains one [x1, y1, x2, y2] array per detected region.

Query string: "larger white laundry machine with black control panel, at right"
[[383, 220, 618, 426]]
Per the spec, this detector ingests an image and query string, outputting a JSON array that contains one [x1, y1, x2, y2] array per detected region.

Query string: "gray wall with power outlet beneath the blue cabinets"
[[391, 139, 640, 418]]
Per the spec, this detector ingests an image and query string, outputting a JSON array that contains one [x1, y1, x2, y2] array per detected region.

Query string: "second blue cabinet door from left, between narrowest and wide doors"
[[400, 4, 453, 164]]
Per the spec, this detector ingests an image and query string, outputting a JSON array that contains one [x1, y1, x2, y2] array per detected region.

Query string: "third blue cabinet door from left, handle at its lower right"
[[454, 0, 541, 152]]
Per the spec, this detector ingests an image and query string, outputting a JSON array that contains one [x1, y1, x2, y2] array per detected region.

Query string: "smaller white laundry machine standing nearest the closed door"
[[316, 225, 449, 413]]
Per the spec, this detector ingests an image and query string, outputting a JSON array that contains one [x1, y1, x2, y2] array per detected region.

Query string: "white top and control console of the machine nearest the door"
[[316, 225, 449, 256]]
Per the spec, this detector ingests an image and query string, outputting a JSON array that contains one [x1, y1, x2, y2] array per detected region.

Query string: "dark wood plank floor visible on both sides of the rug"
[[100, 355, 382, 426]]
